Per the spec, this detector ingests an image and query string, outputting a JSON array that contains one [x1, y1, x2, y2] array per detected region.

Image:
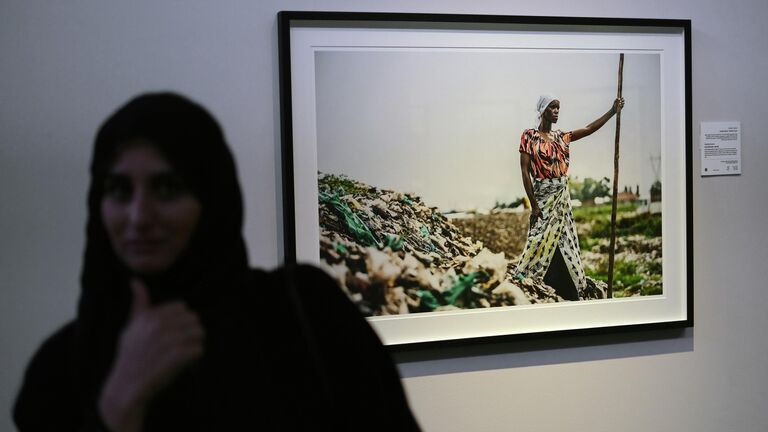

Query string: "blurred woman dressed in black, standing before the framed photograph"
[[14, 93, 419, 432]]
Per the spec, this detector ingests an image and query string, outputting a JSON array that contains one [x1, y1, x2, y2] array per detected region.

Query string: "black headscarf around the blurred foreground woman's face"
[[77, 93, 248, 400]]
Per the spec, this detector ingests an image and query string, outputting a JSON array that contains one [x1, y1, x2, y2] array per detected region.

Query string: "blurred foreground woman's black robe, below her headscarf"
[[14, 266, 418, 432]]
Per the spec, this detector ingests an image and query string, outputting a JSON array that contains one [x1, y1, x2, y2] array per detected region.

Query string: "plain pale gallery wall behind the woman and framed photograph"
[[0, 0, 768, 432]]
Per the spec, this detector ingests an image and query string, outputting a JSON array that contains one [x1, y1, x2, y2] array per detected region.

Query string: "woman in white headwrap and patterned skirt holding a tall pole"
[[516, 94, 624, 300]]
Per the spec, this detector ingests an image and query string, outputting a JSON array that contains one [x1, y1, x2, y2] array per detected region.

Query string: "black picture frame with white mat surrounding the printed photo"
[[277, 11, 693, 348]]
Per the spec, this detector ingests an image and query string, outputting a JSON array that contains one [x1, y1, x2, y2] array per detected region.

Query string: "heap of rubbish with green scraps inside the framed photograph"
[[319, 173, 605, 315]]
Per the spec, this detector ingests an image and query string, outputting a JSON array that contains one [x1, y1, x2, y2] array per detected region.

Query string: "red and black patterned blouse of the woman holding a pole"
[[520, 129, 571, 179]]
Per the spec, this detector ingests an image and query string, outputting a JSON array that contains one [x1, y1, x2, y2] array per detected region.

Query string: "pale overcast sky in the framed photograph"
[[315, 50, 661, 211]]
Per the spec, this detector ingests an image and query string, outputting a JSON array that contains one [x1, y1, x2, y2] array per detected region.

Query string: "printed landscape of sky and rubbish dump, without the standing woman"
[[314, 48, 664, 316]]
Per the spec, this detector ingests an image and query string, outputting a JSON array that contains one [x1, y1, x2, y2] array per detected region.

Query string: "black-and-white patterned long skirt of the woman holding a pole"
[[516, 177, 587, 297]]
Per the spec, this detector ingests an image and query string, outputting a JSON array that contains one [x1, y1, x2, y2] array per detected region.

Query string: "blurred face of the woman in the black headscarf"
[[101, 140, 201, 274]]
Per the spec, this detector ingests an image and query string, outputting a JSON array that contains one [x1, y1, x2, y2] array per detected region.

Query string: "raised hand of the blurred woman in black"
[[99, 279, 205, 431]]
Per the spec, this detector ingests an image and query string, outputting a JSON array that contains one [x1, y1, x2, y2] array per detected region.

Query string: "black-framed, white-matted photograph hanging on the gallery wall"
[[278, 12, 693, 346]]
